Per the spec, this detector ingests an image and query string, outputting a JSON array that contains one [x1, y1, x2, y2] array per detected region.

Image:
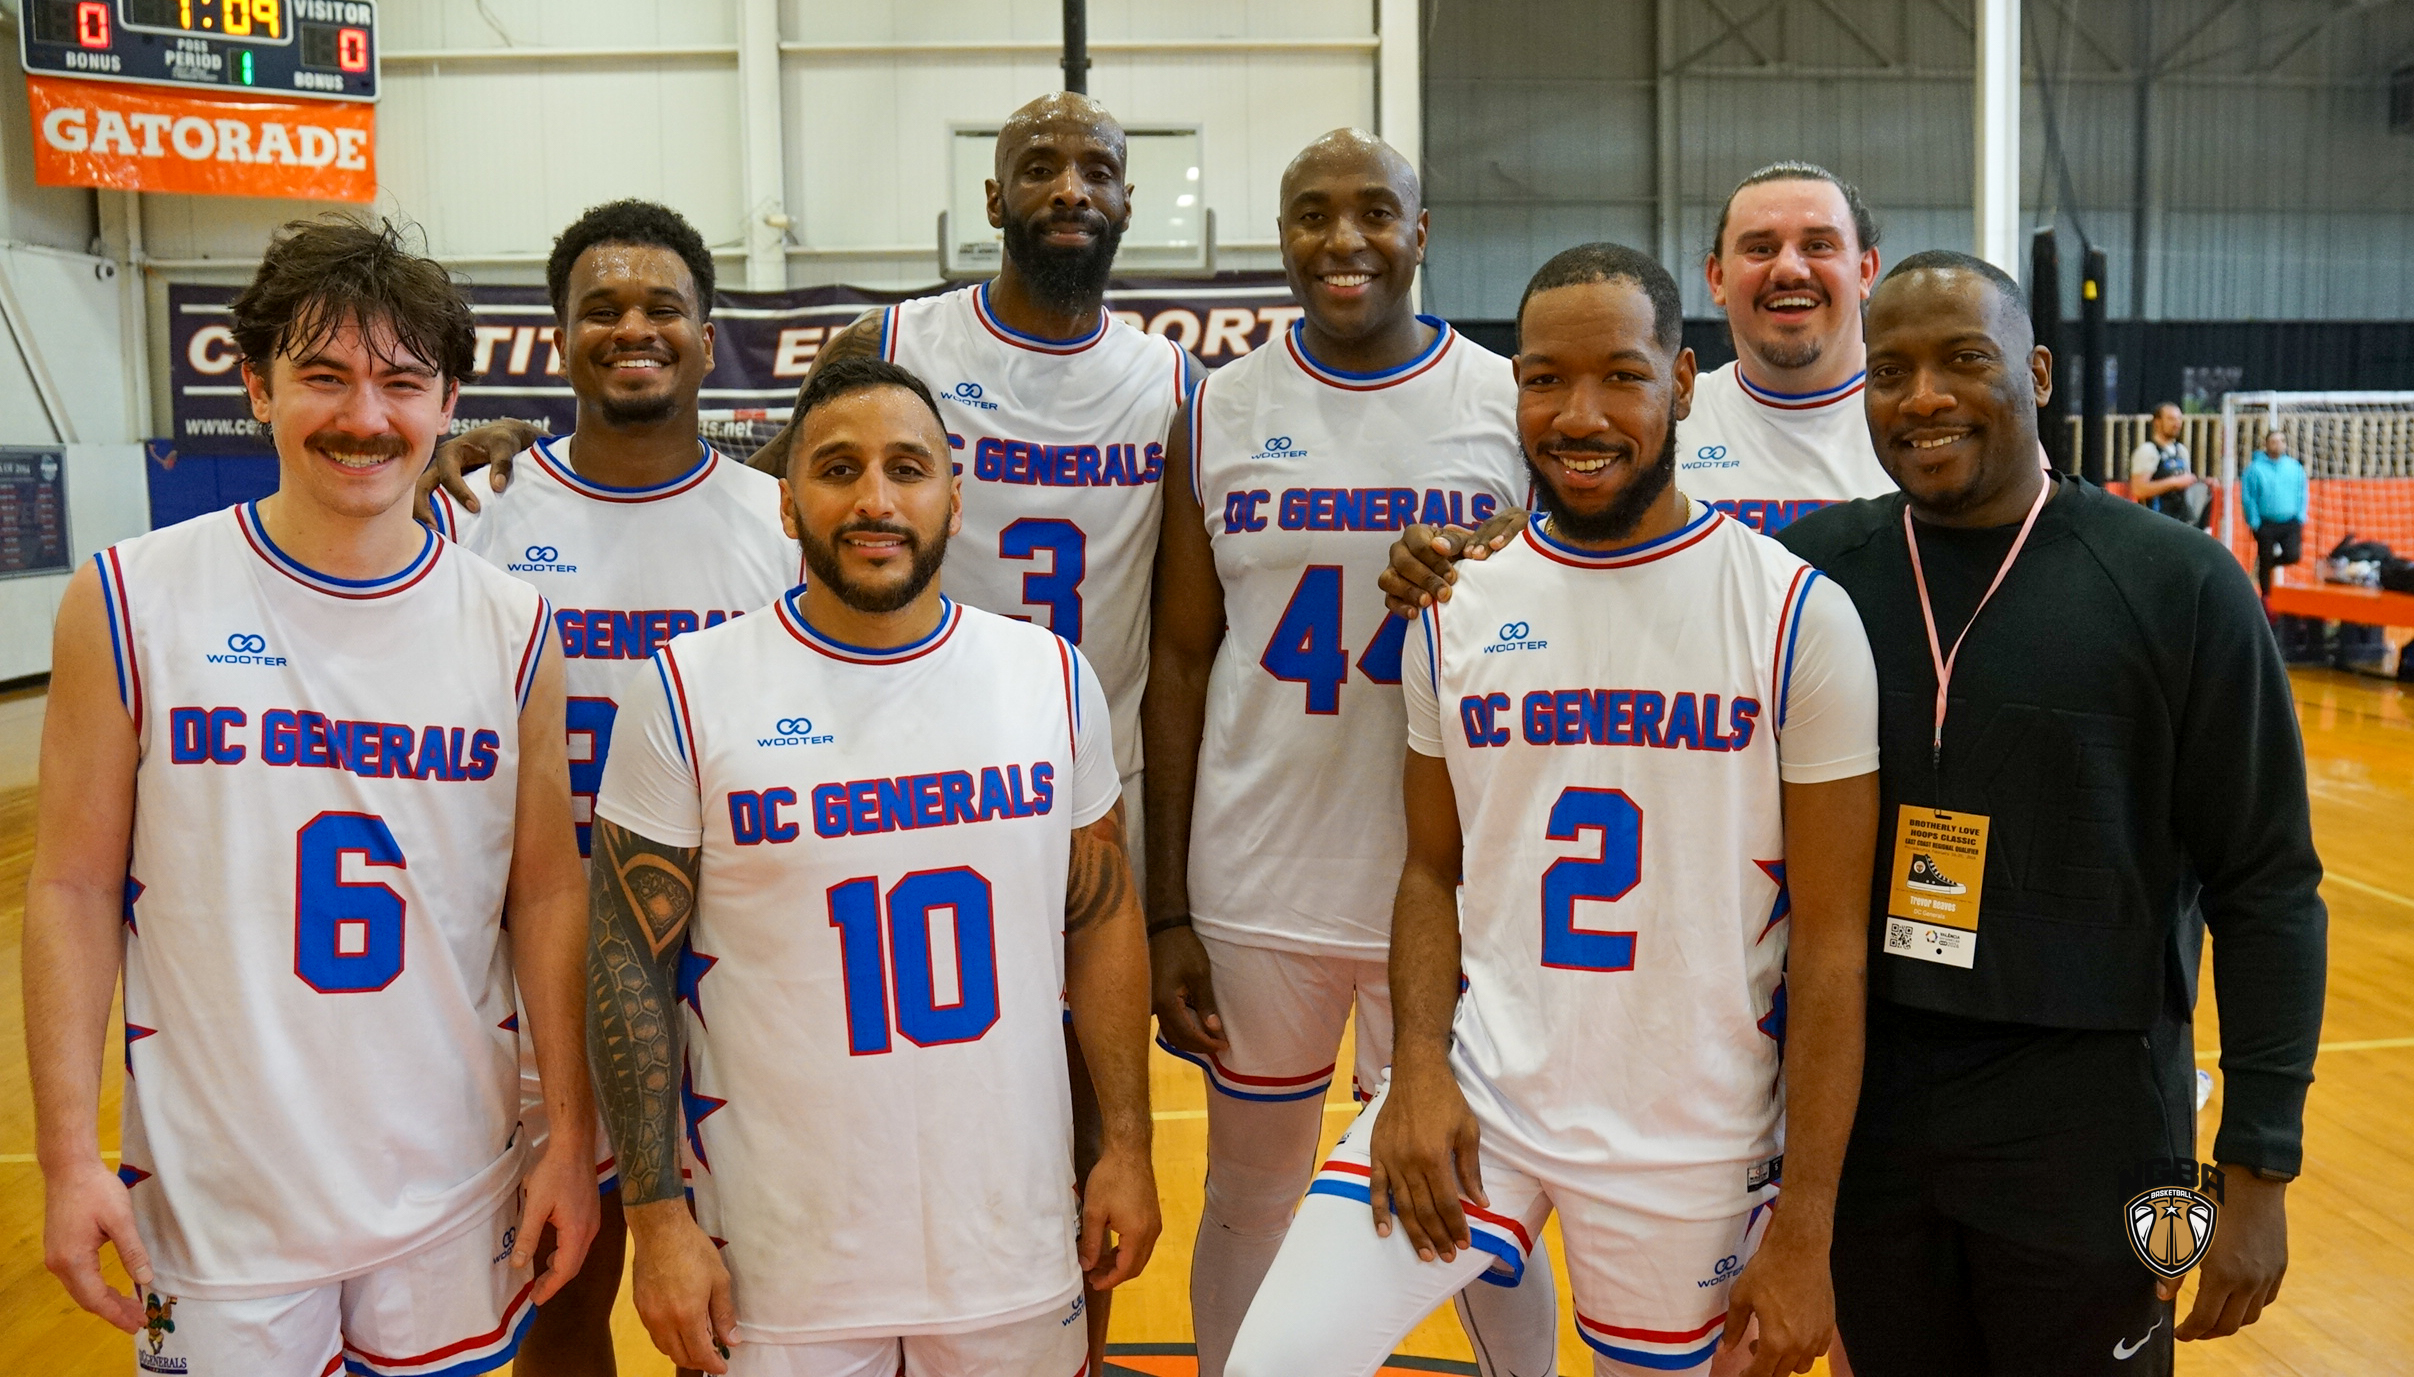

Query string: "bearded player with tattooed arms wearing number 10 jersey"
[[589, 358, 1159, 1377]]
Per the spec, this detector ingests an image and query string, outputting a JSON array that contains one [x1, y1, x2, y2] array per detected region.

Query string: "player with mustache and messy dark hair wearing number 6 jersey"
[[24, 220, 596, 1377]]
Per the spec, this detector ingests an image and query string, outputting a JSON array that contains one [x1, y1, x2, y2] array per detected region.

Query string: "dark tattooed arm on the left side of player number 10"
[[587, 819, 702, 1205]]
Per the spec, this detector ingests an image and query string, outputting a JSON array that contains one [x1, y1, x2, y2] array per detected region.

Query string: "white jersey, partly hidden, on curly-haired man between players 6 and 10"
[[430, 440, 804, 855]]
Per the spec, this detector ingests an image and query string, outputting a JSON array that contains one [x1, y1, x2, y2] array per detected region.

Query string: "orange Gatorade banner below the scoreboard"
[[24, 75, 377, 201]]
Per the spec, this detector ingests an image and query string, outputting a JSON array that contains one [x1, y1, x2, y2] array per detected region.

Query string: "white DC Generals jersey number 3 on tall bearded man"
[[881, 283, 1190, 775]]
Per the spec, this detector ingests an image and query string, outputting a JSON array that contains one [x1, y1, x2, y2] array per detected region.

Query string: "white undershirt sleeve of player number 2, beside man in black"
[[1777, 577, 1878, 785]]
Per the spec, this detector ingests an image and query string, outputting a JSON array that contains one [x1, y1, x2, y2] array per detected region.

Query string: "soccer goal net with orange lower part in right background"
[[2216, 391, 2414, 585]]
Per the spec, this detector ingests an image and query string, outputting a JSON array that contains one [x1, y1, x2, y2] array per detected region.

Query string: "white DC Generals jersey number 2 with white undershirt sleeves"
[[1403, 505, 1878, 1220]]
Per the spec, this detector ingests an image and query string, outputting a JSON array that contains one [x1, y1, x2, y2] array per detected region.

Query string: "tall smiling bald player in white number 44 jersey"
[[1144, 128, 1557, 1377]]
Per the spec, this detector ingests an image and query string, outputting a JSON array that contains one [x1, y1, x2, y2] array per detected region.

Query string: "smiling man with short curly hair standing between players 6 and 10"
[[427, 201, 804, 1377]]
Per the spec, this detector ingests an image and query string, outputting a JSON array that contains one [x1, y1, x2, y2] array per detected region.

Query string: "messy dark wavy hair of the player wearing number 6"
[[232, 215, 478, 384]]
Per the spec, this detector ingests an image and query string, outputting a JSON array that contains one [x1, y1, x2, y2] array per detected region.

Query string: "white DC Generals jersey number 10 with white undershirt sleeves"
[[596, 594, 1120, 1343]]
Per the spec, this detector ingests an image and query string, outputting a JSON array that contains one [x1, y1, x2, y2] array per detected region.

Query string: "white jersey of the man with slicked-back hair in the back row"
[[1675, 362, 1895, 536]]
